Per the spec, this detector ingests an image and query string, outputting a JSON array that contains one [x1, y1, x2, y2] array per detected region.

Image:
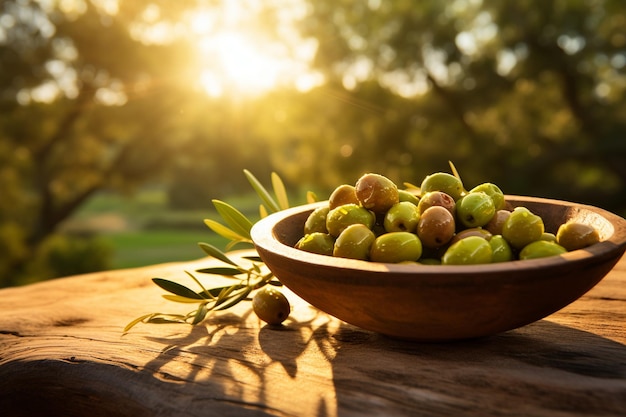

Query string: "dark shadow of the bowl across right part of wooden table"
[[316, 320, 626, 416]]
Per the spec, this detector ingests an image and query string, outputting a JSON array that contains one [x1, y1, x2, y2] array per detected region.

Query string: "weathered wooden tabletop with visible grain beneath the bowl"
[[0, 250, 626, 417]]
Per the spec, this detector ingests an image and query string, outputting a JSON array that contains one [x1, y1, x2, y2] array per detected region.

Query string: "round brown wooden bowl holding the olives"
[[252, 196, 626, 342]]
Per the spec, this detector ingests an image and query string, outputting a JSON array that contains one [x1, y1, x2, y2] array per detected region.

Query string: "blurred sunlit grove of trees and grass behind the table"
[[0, 0, 626, 287]]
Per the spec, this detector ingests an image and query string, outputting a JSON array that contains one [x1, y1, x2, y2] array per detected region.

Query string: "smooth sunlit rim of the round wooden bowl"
[[250, 195, 626, 276]]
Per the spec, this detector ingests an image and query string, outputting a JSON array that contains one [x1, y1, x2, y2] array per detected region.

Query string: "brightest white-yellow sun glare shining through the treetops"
[[189, 1, 322, 97]]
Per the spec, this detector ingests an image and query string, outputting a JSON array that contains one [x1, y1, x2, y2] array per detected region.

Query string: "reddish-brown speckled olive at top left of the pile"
[[354, 173, 400, 214]]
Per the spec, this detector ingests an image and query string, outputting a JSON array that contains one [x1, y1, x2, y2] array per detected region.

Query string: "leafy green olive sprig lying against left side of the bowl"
[[124, 170, 317, 333]]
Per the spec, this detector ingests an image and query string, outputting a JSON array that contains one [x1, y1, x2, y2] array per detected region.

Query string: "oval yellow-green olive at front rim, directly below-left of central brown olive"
[[370, 232, 422, 263]]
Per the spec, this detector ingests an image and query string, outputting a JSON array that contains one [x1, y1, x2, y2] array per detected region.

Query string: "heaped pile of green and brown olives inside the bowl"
[[295, 172, 600, 265]]
